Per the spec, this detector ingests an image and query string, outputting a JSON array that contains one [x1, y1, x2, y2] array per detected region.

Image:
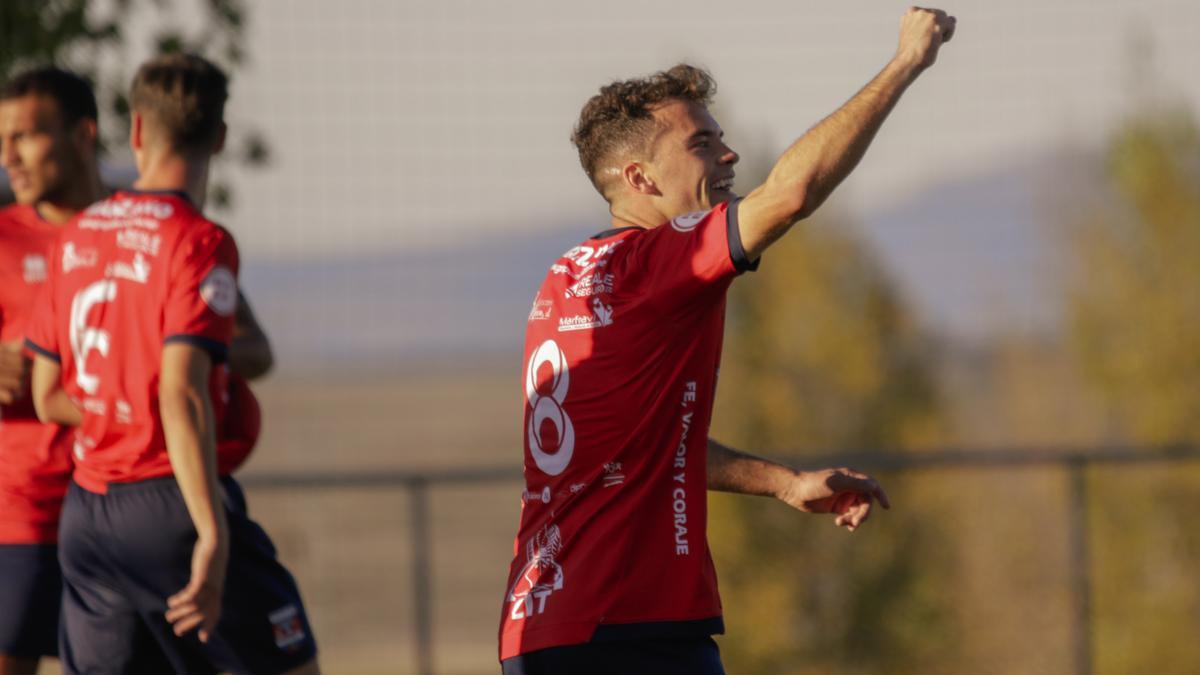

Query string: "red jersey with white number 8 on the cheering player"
[[500, 203, 752, 659]]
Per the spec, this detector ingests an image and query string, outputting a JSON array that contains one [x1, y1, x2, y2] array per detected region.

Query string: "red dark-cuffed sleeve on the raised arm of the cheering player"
[[629, 201, 758, 303]]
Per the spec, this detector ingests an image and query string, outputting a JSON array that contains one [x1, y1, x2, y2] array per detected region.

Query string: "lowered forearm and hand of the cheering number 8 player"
[[708, 438, 892, 532]]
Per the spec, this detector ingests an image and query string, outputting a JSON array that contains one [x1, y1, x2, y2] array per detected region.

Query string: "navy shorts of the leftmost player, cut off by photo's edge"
[[0, 544, 62, 658]]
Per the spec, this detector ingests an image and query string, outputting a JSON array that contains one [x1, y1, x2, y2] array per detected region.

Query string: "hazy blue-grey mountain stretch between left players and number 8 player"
[[242, 226, 583, 371]]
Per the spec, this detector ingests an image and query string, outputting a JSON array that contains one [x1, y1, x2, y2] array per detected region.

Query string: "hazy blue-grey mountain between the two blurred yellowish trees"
[[862, 154, 1097, 341]]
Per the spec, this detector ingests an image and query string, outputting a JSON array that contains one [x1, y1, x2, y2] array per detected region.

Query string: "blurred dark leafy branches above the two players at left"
[[0, 0, 270, 208]]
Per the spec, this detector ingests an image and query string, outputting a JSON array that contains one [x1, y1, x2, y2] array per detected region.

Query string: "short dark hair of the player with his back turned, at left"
[[130, 54, 229, 151]]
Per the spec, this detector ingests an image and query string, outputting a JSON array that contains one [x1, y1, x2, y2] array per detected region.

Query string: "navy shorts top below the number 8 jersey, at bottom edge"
[[500, 637, 725, 675]]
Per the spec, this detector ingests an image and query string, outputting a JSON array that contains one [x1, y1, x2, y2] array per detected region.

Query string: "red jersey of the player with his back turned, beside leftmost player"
[[29, 191, 238, 492]]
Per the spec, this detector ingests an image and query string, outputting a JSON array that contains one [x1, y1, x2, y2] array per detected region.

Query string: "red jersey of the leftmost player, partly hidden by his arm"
[[0, 205, 71, 544]]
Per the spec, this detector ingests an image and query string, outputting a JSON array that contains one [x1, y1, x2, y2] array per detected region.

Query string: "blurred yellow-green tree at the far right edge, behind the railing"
[[1068, 108, 1200, 674]]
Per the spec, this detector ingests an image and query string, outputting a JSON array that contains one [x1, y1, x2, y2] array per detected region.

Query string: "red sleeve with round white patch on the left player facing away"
[[163, 225, 238, 363]]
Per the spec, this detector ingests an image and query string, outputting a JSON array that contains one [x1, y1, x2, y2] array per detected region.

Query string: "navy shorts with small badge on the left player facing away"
[[59, 477, 317, 675]]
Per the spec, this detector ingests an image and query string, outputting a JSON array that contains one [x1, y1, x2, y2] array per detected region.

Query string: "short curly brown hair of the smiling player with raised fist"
[[571, 64, 716, 198]]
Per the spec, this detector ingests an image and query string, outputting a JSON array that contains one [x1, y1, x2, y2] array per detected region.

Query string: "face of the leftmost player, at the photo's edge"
[[0, 95, 83, 204]]
